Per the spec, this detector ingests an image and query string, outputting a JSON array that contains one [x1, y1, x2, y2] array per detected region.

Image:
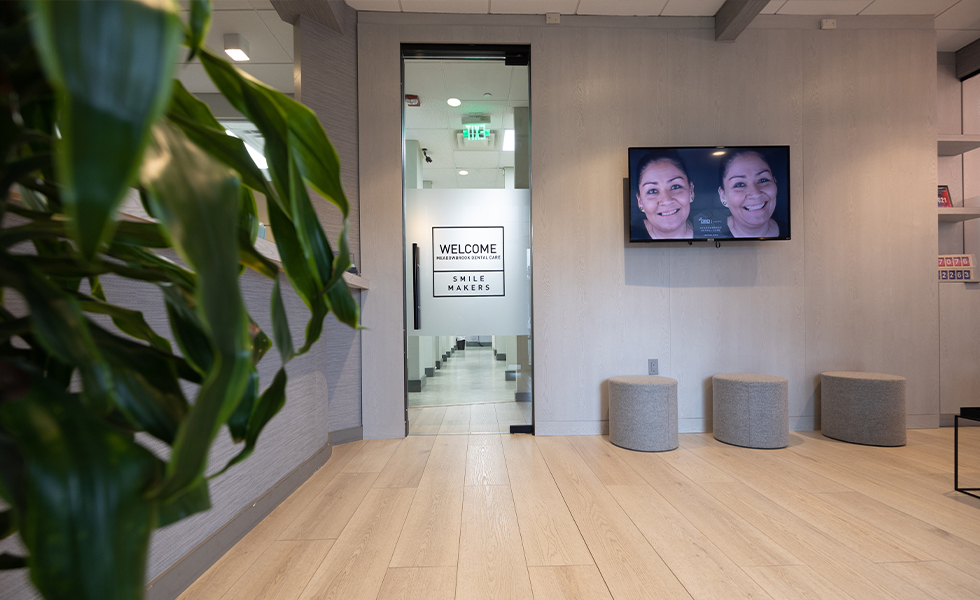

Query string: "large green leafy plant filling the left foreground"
[[0, 0, 359, 600]]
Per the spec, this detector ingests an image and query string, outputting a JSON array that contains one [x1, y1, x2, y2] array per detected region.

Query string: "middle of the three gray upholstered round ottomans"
[[711, 373, 789, 448]]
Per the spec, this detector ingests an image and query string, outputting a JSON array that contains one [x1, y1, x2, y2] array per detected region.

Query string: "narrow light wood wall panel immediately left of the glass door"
[[357, 25, 405, 439]]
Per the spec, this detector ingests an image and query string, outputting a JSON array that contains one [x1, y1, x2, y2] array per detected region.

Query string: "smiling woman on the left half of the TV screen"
[[631, 150, 694, 240]]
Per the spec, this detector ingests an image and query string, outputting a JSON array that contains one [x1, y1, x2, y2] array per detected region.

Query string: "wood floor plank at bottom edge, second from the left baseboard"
[[217, 540, 334, 600]]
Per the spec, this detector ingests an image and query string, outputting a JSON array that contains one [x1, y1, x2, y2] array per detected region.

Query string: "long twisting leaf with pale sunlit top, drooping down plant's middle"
[[142, 121, 252, 501]]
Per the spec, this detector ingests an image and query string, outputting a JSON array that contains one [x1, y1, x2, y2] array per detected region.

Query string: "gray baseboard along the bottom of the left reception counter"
[[145, 438, 334, 600]]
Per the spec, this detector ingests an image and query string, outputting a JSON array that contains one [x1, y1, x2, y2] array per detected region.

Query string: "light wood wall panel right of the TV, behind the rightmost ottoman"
[[802, 31, 939, 426]]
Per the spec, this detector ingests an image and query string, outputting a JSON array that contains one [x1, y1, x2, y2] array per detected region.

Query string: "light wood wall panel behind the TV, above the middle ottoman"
[[668, 30, 814, 431]]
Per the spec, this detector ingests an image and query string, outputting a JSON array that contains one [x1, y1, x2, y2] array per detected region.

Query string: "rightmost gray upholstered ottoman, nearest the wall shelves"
[[820, 371, 905, 446]]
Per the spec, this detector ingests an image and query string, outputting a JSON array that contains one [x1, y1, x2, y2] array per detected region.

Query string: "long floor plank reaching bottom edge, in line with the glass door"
[[456, 485, 533, 600]]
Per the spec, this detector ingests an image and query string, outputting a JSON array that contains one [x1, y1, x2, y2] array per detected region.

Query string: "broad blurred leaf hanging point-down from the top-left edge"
[[30, 0, 182, 258]]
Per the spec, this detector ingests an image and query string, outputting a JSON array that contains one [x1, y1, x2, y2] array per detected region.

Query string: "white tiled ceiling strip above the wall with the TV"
[[346, 0, 980, 52]]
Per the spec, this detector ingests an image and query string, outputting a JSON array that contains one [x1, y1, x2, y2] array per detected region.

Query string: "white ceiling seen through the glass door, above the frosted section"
[[405, 60, 528, 189]]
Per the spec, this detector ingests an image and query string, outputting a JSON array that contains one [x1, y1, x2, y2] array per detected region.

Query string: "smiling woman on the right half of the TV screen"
[[718, 150, 779, 238]]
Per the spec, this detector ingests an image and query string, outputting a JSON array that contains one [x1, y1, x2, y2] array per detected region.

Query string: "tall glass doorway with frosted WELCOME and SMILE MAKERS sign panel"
[[402, 45, 534, 435]]
